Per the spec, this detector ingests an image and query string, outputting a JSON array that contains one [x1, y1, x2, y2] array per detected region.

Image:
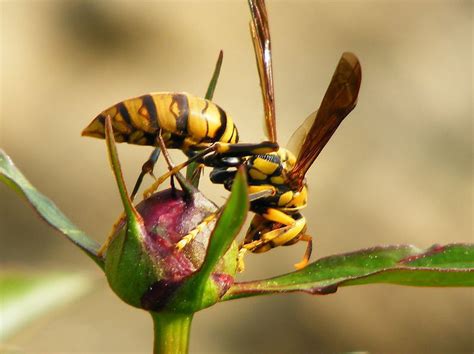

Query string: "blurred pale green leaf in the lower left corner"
[[0, 271, 92, 341]]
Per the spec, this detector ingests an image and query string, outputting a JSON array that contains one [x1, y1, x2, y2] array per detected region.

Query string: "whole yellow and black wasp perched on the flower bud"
[[83, 0, 361, 269]]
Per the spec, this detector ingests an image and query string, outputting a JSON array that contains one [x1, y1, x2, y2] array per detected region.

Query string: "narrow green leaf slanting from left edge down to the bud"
[[0, 149, 103, 267]]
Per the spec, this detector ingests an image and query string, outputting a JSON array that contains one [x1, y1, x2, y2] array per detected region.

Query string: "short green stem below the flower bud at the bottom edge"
[[151, 312, 193, 354]]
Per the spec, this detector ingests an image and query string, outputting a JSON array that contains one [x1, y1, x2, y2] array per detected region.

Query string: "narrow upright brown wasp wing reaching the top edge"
[[248, 0, 277, 142]]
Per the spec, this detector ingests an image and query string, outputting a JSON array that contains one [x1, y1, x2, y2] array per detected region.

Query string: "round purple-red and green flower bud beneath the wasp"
[[105, 189, 236, 311]]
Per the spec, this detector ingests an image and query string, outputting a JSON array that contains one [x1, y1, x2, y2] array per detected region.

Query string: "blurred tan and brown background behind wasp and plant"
[[0, 0, 474, 353]]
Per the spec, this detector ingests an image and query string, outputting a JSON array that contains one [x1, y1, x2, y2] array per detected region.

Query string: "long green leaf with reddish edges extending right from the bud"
[[224, 244, 474, 300]]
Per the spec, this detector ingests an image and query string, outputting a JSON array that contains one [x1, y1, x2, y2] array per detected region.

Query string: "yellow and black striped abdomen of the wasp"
[[82, 92, 238, 150]]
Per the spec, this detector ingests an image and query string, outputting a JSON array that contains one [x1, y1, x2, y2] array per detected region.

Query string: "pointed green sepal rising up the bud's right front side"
[[173, 168, 249, 312]]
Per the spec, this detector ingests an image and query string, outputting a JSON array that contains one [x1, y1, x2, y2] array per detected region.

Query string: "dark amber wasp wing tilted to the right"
[[289, 52, 362, 187]]
